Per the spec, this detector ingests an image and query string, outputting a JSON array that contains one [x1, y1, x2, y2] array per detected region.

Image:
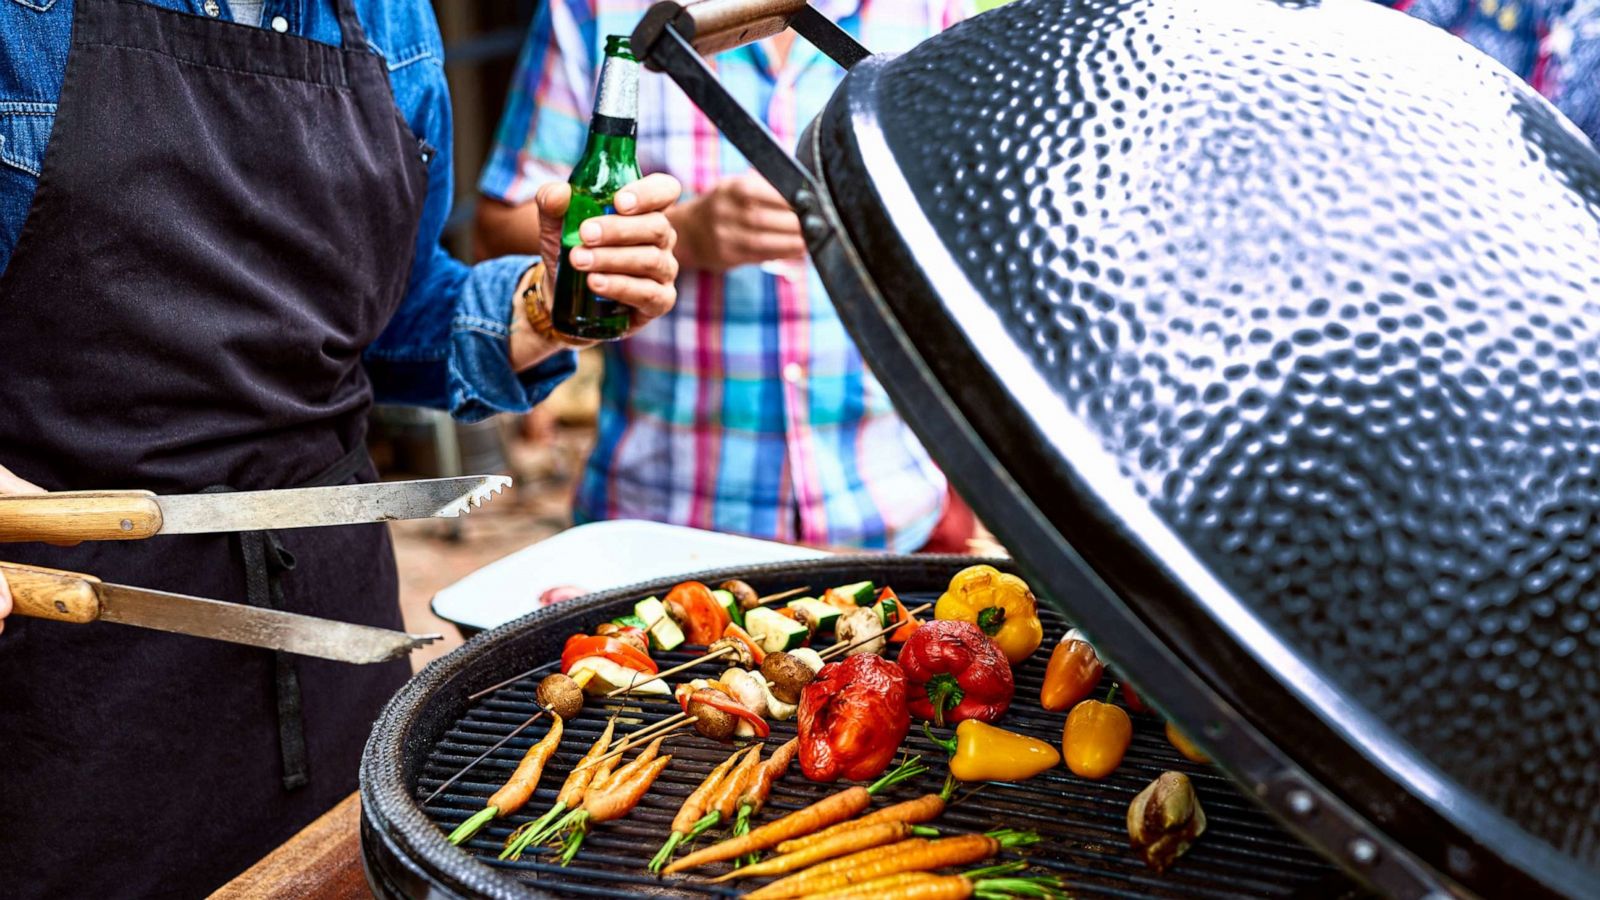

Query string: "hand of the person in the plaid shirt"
[[667, 171, 805, 272]]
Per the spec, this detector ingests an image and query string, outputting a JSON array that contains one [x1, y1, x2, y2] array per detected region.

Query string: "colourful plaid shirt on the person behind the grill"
[[478, 0, 970, 552]]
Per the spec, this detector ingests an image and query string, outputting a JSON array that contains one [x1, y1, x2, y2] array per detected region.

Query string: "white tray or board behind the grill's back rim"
[[434, 519, 827, 629]]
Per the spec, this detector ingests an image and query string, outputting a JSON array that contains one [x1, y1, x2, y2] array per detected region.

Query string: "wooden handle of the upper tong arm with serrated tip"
[[0, 490, 162, 541]]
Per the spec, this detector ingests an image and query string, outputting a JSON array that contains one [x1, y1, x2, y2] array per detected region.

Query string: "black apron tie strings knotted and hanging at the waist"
[[200, 441, 368, 791]]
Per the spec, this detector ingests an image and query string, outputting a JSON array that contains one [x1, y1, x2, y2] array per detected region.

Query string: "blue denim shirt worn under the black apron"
[[0, 0, 574, 421]]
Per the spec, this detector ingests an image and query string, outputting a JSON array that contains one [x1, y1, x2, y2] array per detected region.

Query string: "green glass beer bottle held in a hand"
[[550, 35, 638, 341]]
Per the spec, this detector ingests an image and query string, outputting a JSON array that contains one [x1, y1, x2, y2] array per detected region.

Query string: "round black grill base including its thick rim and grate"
[[362, 557, 1355, 898]]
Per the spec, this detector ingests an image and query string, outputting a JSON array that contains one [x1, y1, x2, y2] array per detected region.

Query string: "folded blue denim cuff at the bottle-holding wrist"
[[450, 256, 578, 421]]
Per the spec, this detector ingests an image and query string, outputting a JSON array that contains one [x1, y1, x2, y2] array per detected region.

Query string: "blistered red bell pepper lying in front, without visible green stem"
[[798, 653, 910, 781]]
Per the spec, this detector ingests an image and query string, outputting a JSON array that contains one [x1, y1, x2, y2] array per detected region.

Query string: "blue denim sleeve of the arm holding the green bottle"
[[362, 3, 576, 421]]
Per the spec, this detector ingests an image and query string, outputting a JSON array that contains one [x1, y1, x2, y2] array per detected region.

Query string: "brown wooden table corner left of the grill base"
[[211, 794, 373, 900]]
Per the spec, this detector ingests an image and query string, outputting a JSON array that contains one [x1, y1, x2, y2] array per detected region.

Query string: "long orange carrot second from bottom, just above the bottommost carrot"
[[744, 830, 1038, 900]]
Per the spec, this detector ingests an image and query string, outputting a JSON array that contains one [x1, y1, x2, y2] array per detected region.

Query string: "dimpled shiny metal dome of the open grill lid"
[[806, 0, 1600, 887]]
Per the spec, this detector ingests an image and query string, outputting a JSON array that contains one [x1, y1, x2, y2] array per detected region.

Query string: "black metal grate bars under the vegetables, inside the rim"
[[416, 594, 1358, 898]]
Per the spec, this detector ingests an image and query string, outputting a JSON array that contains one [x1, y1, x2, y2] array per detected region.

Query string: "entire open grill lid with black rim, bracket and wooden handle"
[[360, 0, 1600, 898]]
